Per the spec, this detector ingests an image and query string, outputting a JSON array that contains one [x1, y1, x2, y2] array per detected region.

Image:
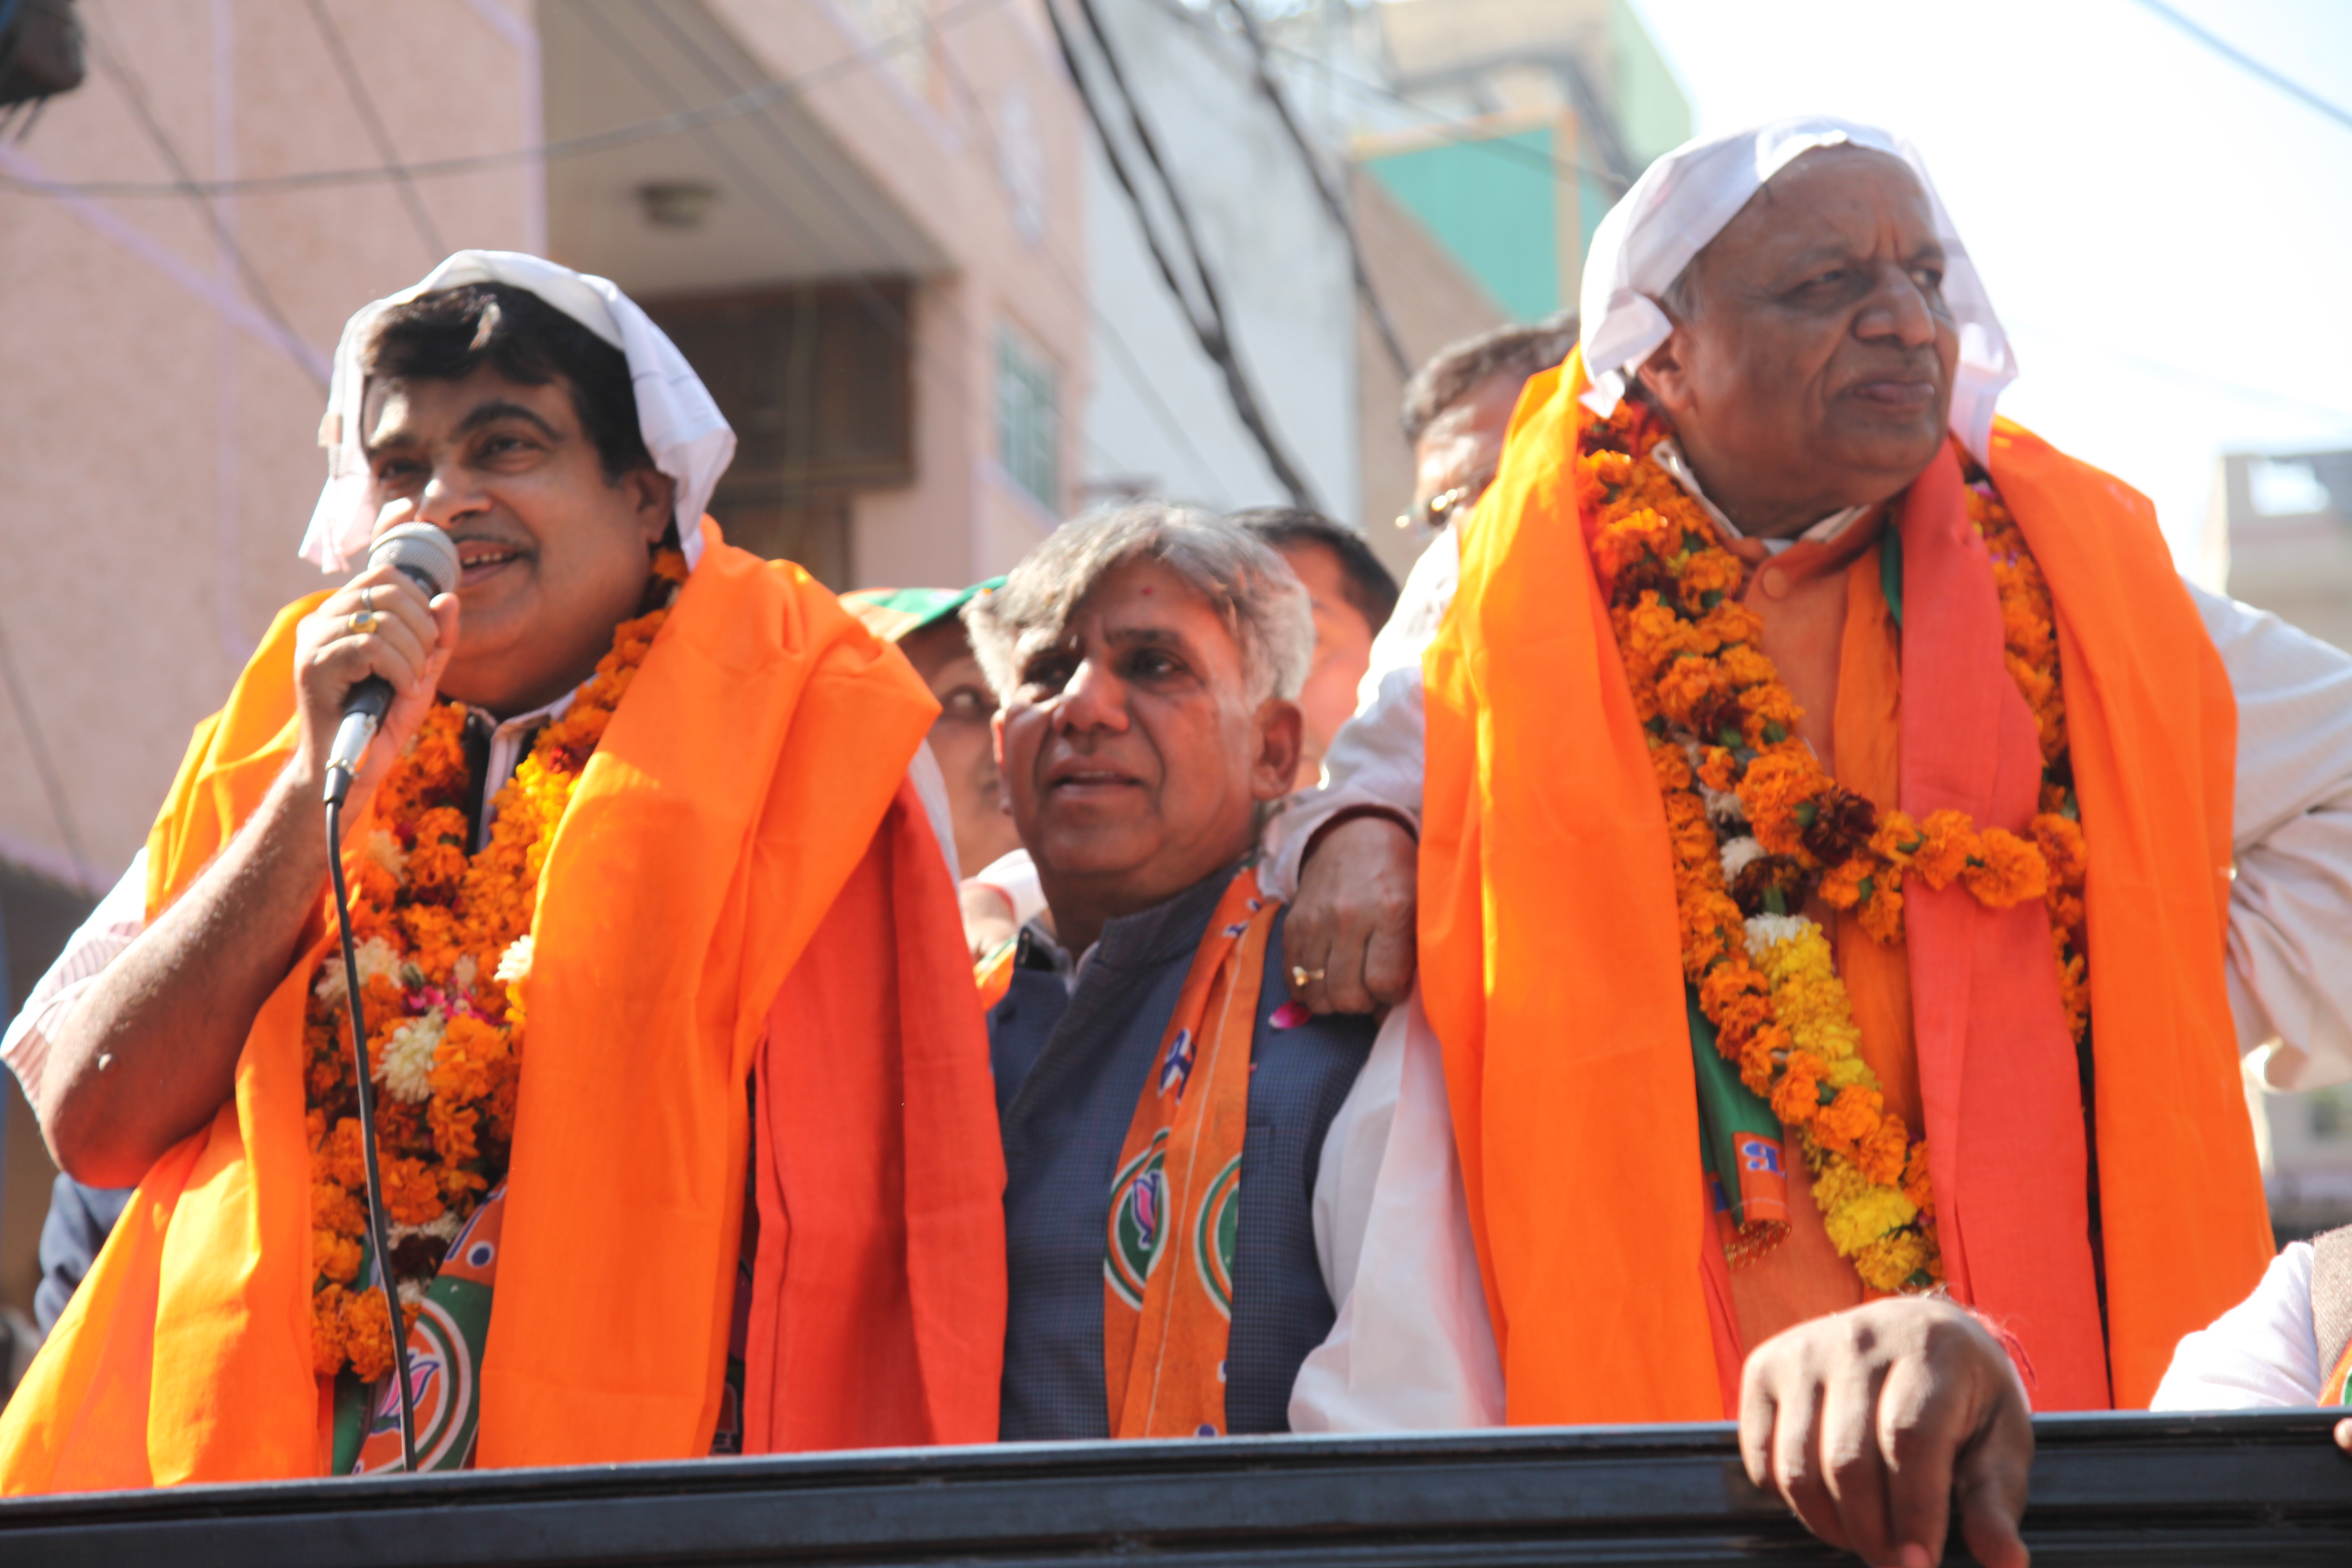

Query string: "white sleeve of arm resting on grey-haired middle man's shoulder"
[[1261, 529, 1461, 898]]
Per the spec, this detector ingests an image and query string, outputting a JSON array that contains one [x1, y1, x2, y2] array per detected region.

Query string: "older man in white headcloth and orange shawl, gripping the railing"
[[1270, 120, 2352, 1561]]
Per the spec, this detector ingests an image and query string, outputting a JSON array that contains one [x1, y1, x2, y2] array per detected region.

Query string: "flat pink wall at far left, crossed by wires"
[[0, 0, 536, 877]]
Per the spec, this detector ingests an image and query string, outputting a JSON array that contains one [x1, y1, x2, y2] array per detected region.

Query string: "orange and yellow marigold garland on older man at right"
[[1576, 402, 2089, 1291]]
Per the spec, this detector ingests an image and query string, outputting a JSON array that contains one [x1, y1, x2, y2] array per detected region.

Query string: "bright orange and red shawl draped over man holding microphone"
[[0, 520, 1004, 1493]]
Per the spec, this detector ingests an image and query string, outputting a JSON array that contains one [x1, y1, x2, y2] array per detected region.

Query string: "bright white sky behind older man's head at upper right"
[[1635, 0, 2352, 583]]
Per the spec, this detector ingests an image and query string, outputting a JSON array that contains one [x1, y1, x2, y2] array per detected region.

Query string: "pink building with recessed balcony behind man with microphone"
[[0, 0, 1089, 1344]]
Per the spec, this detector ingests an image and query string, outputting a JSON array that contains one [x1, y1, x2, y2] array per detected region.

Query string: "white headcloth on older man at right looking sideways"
[[1578, 118, 2018, 461]]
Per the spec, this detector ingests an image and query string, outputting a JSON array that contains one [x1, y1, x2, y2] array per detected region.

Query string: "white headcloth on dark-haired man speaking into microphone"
[[301, 252, 734, 571]]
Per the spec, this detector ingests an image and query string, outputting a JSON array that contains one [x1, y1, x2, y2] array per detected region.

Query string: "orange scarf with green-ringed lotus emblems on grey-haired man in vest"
[[1103, 865, 1282, 1436]]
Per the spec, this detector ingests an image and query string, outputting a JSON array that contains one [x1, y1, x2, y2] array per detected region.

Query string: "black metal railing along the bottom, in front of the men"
[[0, 1411, 2352, 1568]]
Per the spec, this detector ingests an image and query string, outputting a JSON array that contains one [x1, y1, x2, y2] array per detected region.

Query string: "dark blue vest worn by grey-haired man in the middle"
[[988, 867, 1374, 1441]]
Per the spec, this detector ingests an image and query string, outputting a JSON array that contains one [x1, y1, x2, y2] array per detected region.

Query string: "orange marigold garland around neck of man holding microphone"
[[303, 550, 684, 1382]]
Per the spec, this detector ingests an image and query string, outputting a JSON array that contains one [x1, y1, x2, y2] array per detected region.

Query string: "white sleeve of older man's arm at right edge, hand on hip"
[[2190, 585, 2352, 1091]]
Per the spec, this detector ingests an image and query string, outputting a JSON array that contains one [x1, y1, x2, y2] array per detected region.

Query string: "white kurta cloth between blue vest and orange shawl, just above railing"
[[1291, 990, 1503, 1431]]
